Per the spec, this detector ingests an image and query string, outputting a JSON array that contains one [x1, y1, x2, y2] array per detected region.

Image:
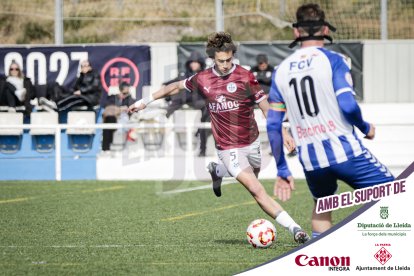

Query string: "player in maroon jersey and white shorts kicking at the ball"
[[129, 32, 309, 243]]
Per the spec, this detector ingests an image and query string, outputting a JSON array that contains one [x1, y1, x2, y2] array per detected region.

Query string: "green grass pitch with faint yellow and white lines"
[[0, 180, 356, 275]]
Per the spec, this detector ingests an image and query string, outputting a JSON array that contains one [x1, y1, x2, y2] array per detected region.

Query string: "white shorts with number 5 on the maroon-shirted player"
[[217, 138, 262, 177]]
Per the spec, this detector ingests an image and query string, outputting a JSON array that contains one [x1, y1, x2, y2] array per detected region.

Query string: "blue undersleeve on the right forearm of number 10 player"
[[336, 92, 370, 135]]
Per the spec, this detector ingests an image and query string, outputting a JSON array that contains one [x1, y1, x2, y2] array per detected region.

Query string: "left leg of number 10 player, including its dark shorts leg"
[[305, 168, 338, 238]]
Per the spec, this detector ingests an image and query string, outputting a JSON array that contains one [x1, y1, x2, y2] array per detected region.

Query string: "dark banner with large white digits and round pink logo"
[[0, 45, 151, 99]]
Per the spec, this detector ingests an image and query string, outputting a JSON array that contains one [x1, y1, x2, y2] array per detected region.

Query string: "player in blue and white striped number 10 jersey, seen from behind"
[[267, 4, 394, 237]]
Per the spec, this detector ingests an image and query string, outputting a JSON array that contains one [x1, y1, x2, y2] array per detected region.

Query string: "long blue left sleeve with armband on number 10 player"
[[267, 71, 292, 178]]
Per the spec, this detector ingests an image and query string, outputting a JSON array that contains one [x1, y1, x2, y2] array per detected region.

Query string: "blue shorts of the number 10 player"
[[305, 150, 394, 199]]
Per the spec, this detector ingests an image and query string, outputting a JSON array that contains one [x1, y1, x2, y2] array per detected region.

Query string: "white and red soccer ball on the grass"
[[247, 219, 276, 248]]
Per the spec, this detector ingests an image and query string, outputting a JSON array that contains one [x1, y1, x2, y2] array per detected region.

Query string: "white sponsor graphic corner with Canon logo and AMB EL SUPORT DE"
[[239, 163, 414, 276]]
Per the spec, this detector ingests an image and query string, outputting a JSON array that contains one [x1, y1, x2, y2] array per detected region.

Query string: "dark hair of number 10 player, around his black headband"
[[296, 3, 325, 34]]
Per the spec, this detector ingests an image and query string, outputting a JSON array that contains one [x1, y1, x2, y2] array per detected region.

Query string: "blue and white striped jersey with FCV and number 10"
[[269, 47, 369, 171]]
